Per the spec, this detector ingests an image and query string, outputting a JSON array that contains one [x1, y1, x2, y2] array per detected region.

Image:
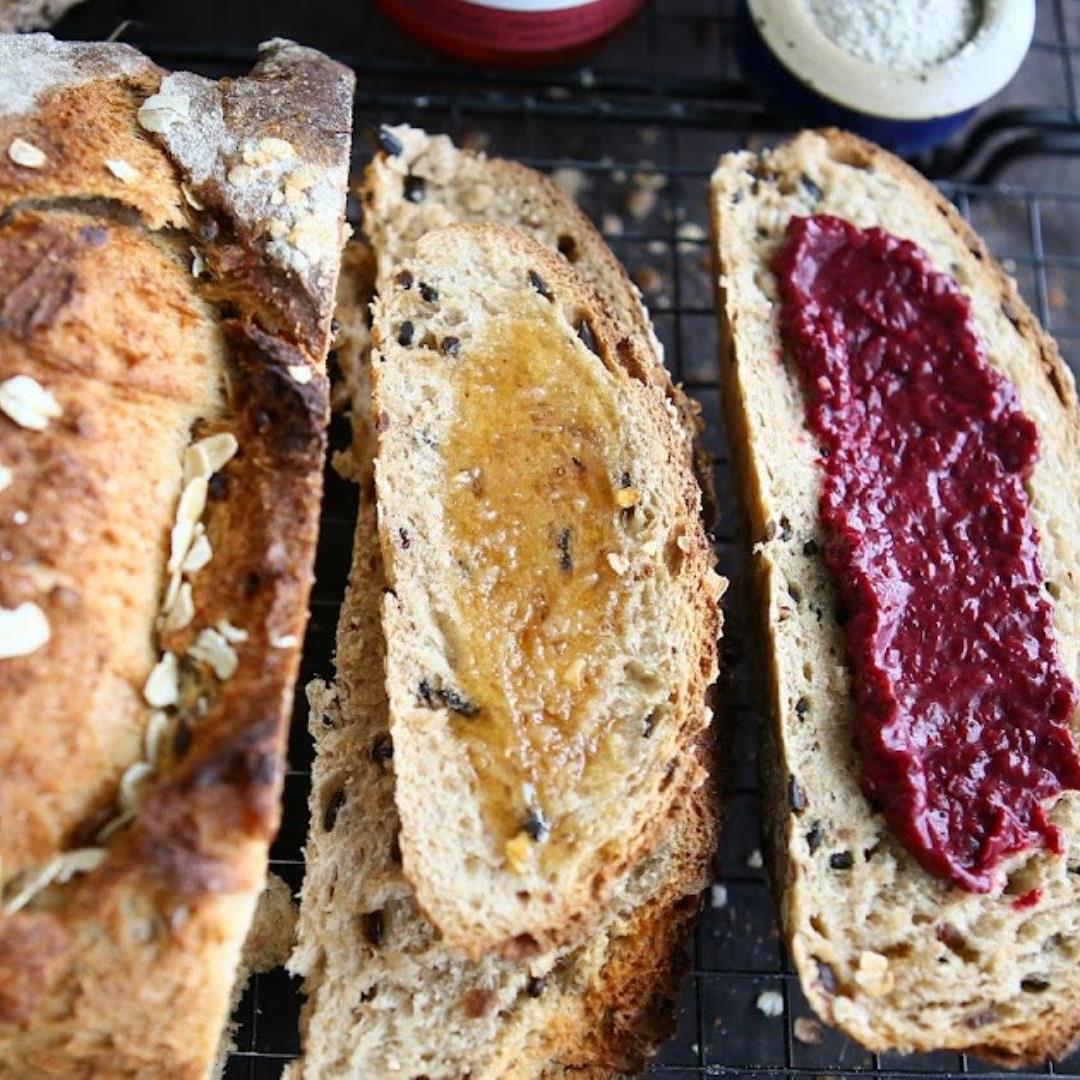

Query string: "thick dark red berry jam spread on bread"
[[774, 216, 1080, 892]]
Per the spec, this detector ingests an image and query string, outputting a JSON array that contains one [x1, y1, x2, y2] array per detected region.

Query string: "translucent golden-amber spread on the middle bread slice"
[[443, 309, 631, 869]]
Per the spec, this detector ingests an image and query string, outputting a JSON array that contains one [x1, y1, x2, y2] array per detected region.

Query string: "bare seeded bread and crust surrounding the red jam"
[[712, 131, 1080, 1065]]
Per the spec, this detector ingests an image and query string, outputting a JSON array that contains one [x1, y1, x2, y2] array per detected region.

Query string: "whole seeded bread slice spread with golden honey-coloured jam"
[[373, 225, 720, 957]]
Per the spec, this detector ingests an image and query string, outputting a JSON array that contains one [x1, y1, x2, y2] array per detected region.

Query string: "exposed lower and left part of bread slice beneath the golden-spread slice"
[[291, 243, 716, 1080]]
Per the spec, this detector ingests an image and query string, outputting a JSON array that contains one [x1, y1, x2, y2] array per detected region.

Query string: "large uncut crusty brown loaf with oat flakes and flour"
[[0, 35, 352, 1077]]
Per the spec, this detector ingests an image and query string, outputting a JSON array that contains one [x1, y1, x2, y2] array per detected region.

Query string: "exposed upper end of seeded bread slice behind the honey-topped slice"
[[361, 124, 707, 449]]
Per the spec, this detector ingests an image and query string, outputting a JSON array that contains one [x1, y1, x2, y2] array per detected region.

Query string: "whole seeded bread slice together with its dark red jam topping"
[[712, 131, 1080, 1066]]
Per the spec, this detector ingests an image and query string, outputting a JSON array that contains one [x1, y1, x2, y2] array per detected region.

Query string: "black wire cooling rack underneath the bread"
[[46, 0, 1080, 1080]]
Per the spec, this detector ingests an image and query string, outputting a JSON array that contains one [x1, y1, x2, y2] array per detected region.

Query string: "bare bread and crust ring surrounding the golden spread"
[[373, 224, 723, 958]]
